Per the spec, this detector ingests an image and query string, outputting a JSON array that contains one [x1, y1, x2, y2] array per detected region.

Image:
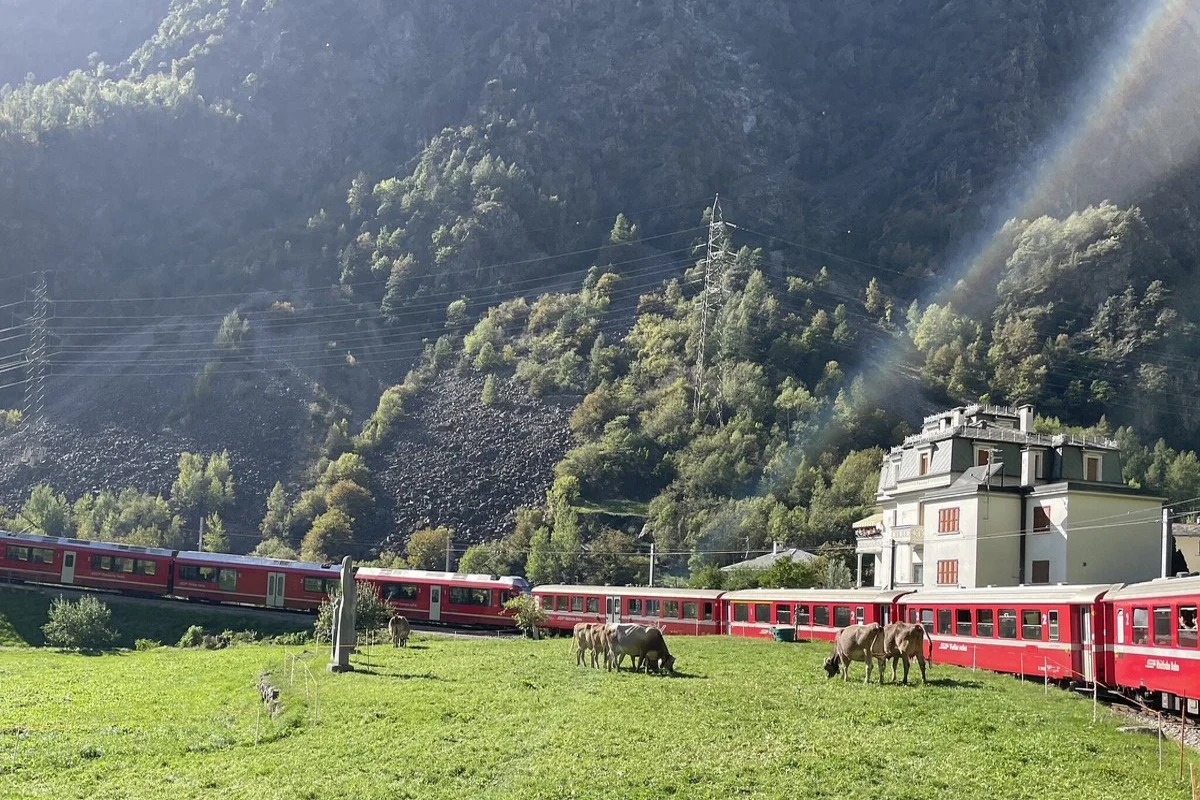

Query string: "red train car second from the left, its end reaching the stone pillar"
[[173, 552, 342, 610]]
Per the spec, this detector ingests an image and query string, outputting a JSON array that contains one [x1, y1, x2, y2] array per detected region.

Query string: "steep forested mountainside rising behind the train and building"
[[0, 0, 1200, 575]]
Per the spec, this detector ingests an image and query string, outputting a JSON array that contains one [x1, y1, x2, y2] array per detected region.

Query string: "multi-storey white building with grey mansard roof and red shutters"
[[854, 405, 1163, 588]]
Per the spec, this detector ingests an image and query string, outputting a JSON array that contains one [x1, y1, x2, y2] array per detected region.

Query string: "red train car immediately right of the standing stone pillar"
[[356, 567, 529, 627]]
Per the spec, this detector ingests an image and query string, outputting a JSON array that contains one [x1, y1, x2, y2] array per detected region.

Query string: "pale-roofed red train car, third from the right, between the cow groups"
[[722, 589, 906, 640]]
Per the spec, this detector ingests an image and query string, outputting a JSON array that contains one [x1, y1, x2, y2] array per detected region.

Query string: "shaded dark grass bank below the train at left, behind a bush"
[[0, 589, 314, 652]]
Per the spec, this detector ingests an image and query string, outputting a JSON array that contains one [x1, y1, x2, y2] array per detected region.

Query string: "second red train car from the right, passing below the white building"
[[899, 584, 1112, 684]]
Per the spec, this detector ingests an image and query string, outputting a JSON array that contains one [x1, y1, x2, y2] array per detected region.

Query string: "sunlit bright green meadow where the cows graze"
[[0, 636, 1188, 800]]
